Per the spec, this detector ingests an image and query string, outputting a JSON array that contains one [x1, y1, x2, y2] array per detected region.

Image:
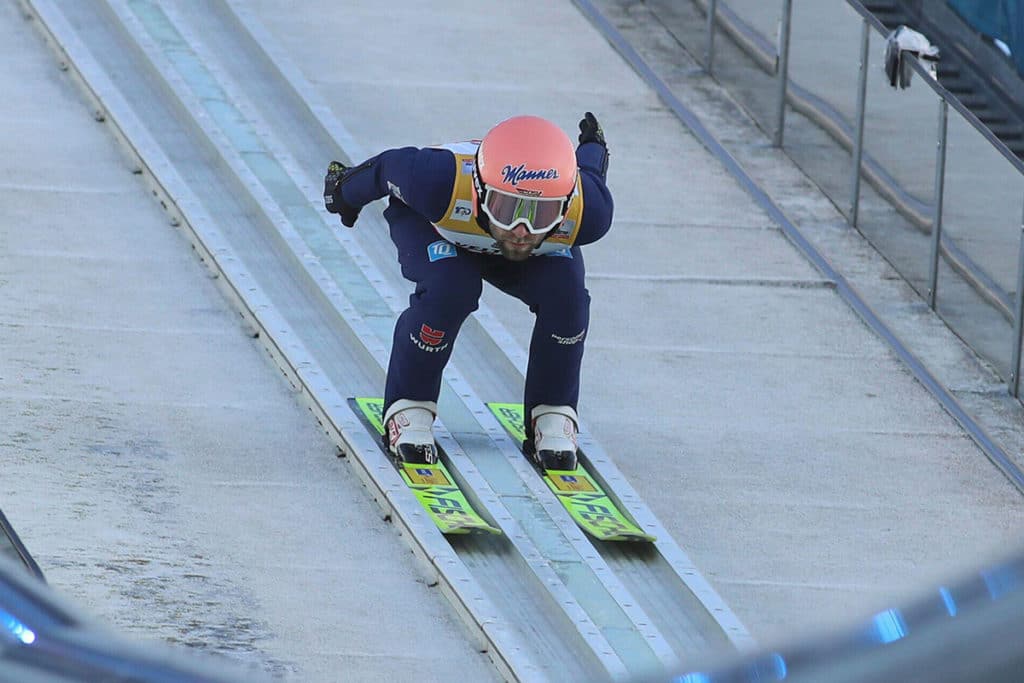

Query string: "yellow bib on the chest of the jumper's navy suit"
[[433, 142, 583, 255]]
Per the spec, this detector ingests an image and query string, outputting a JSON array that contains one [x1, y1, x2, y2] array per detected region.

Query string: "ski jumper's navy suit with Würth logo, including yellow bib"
[[341, 142, 612, 428]]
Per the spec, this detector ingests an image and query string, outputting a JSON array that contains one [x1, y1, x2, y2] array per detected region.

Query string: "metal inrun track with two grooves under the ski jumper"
[[20, 0, 749, 680]]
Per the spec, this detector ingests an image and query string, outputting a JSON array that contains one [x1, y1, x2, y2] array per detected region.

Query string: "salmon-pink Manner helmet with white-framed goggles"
[[473, 116, 578, 234]]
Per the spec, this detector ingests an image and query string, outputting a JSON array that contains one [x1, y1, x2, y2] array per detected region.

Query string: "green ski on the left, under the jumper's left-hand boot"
[[348, 397, 502, 533]]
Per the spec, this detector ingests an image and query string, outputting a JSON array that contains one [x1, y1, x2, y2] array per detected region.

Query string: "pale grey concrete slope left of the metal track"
[[0, 2, 496, 682]]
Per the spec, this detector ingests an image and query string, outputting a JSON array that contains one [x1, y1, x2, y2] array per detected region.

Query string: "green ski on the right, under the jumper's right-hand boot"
[[487, 403, 657, 542]]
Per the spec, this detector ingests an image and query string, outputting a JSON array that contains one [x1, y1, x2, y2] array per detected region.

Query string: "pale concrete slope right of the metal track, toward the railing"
[[237, 0, 1024, 639]]
